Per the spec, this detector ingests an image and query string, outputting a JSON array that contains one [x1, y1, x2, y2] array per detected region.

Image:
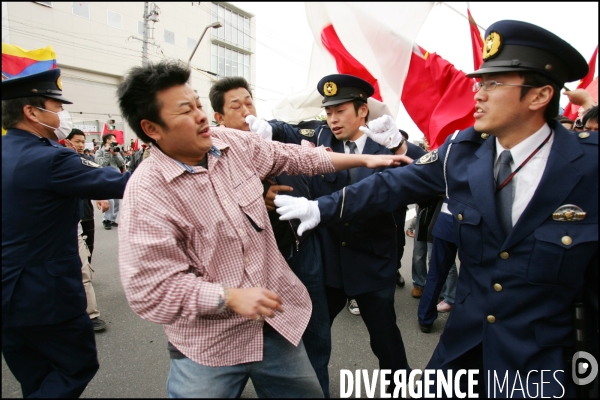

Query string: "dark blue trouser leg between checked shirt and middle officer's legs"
[[287, 234, 331, 397]]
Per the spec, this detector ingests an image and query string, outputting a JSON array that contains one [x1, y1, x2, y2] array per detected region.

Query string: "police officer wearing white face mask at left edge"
[[2, 69, 129, 397]]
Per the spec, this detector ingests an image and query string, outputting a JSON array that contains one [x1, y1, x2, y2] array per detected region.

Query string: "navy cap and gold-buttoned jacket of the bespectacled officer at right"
[[318, 21, 598, 397]]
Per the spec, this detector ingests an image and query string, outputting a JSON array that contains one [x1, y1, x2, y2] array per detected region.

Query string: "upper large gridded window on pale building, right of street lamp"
[[210, 3, 250, 50]]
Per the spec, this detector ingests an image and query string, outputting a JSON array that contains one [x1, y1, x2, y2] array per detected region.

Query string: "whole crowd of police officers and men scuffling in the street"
[[2, 17, 598, 397]]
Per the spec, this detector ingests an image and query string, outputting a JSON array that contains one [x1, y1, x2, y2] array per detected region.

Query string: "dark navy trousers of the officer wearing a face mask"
[[2, 313, 99, 398]]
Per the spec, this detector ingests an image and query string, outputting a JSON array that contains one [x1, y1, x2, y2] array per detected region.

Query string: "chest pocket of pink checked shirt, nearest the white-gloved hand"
[[233, 174, 269, 232]]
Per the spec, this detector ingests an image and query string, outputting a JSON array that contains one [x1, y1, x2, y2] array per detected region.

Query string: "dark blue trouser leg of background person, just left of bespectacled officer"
[[417, 236, 458, 325]]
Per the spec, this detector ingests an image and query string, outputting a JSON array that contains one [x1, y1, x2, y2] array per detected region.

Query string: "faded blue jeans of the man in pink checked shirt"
[[167, 326, 323, 398]]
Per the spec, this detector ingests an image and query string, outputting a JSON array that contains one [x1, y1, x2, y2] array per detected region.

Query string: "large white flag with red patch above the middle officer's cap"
[[272, 2, 434, 123]]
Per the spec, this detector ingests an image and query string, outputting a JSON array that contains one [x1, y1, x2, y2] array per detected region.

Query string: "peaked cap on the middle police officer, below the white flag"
[[317, 74, 375, 107]]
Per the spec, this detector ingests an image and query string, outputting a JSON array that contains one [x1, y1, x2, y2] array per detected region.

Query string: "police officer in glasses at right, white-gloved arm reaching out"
[[275, 21, 598, 397]]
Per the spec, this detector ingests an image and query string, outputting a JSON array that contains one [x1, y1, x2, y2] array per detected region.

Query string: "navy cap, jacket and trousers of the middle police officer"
[[271, 75, 409, 378]]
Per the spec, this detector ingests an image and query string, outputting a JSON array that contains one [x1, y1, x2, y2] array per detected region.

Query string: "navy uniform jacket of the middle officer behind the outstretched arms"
[[271, 122, 404, 296]]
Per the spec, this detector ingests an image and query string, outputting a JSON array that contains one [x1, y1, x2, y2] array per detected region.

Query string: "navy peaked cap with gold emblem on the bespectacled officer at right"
[[467, 20, 588, 86]]
